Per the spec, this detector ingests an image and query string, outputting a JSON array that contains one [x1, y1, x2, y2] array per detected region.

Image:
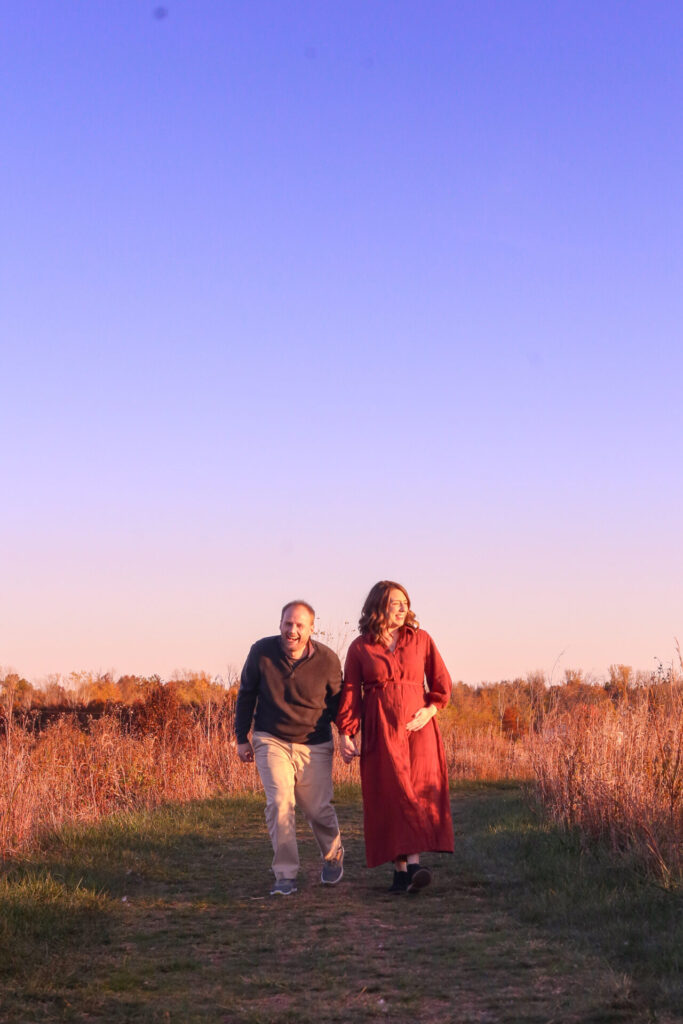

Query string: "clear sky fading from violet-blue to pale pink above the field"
[[0, 0, 683, 683]]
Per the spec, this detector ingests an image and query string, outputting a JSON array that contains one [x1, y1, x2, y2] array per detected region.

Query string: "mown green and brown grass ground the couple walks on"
[[0, 784, 683, 1024]]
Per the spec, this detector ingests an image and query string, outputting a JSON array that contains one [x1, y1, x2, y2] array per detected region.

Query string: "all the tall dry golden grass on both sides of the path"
[[0, 686, 683, 882]]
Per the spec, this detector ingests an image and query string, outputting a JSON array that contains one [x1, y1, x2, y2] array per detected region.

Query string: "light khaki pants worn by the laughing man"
[[252, 732, 341, 879]]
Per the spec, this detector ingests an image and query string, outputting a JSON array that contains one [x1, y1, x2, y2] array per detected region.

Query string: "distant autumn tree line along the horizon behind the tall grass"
[[0, 664, 681, 740]]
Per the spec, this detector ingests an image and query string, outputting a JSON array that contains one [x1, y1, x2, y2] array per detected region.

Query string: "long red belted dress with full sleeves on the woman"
[[336, 627, 453, 867]]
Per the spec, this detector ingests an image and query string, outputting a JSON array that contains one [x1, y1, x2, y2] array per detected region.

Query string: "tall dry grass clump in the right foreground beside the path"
[[529, 687, 683, 883]]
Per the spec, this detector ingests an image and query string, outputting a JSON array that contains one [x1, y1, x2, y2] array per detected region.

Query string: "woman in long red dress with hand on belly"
[[336, 580, 453, 893]]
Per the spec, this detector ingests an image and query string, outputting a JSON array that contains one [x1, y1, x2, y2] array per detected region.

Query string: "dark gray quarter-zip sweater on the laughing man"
[[234, 636, 341, 743]]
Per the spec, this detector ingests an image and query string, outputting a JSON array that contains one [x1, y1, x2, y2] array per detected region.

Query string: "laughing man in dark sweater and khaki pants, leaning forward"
[[234, 601, 344, 896]]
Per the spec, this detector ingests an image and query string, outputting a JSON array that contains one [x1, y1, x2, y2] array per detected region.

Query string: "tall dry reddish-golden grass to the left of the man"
[[0, 714, 258, 857]]
